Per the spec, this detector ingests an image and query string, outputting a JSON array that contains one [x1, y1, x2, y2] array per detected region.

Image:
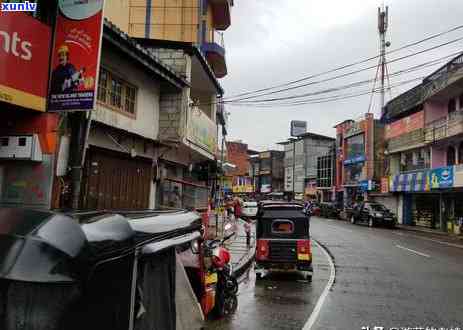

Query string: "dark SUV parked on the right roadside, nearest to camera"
[[350, 202, 397, 228]]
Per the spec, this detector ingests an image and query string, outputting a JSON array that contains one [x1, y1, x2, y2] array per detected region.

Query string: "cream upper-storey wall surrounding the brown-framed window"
[[93, 48, 160, 140]]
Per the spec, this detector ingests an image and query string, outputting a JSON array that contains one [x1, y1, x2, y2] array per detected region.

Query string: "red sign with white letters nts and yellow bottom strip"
[[0, 11, 51, 111]]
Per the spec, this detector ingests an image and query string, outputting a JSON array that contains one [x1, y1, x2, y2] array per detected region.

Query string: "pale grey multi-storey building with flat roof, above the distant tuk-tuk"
[[280, 133, 335, 198]]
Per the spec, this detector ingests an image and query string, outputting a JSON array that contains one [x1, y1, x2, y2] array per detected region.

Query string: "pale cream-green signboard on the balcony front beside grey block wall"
[[187, 108, 217, 155]]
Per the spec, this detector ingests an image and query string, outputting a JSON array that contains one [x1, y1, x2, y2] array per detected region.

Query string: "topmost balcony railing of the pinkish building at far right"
[[425, 111, 463, 143]]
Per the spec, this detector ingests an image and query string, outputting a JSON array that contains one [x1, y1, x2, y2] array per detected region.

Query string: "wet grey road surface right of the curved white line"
[[311, 219, 463, 330]]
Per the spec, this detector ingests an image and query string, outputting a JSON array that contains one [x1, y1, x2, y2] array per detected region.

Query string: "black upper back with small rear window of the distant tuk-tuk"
[[257, 208, 309, 239]]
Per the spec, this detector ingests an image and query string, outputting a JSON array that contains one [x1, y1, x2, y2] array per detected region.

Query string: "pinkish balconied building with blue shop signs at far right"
[[384, 55, 463, 231]]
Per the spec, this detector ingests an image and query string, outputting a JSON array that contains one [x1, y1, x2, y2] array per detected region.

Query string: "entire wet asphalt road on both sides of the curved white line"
[[207, 218, 463, 330]]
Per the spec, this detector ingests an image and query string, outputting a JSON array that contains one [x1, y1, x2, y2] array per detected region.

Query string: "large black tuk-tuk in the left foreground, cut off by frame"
[[0, 208, 203, 330]]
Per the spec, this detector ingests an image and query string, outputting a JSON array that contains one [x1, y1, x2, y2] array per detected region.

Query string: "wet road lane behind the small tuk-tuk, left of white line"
[[206, 240, 330, 330]]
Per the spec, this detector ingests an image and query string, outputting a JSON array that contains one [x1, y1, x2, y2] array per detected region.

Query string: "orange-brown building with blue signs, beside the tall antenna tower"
[[335, 113, 385, 206]]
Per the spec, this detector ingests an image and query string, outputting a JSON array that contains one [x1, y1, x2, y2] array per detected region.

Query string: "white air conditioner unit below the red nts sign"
[[0, 134, 42, 162]]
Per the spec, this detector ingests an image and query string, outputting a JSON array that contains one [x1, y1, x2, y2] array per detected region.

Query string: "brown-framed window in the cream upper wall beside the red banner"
[[97, 68, 137, 116]]
